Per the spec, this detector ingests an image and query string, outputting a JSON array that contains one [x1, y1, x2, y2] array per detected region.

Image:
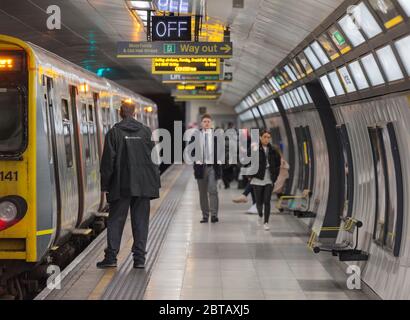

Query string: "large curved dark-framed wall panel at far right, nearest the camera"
[[368, 123, 404, 257]]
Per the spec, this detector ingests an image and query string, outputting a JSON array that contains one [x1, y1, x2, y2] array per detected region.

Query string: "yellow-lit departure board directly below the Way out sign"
[[152, 57, 221, 75]]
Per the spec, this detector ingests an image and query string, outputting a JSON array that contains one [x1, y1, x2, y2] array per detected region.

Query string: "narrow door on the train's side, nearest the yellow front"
[[43, 76, 62, 239]]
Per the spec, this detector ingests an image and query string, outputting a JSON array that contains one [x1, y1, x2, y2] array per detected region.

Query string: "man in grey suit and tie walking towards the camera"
[[194, 114, 222, 223]]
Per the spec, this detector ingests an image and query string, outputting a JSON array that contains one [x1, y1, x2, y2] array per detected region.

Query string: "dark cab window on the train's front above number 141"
[[0, 88, 27, 155]]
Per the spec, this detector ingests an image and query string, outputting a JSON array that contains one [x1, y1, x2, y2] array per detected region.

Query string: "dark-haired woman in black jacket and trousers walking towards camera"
[[251, 130, 281, 231]]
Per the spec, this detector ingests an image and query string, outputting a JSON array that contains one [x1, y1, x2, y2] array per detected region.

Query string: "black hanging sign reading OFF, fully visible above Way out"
[[151, 16, 192, 41]]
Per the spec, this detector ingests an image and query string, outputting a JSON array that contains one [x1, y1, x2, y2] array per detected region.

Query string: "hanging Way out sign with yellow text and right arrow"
[[117, 41, 233, 58]]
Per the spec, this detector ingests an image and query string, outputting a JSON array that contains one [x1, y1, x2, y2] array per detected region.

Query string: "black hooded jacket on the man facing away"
[[100, 117, 161, 202]]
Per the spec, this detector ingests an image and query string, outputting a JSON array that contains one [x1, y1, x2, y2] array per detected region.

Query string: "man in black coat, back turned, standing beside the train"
[[97, 102, 161, 269]]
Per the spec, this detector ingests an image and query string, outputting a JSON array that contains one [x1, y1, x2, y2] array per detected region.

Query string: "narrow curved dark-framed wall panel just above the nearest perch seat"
[[337, 124, 354, 218]]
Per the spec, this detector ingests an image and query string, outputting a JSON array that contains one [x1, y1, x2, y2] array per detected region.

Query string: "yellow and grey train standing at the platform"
[[0, 35, 158, 296]]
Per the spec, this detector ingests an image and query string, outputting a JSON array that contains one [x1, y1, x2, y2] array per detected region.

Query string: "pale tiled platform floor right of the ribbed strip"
[[144, 178, 370, 300]]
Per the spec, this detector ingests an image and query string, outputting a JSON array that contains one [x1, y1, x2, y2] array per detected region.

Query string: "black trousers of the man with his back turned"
[[105, 197, 150, 263]]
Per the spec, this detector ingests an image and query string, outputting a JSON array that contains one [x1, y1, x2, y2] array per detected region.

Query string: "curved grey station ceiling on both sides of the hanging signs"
[[0, 0, 343, 106]]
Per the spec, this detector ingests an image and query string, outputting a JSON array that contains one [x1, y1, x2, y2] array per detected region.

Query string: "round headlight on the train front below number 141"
[[0, 196, 27, 231]]
